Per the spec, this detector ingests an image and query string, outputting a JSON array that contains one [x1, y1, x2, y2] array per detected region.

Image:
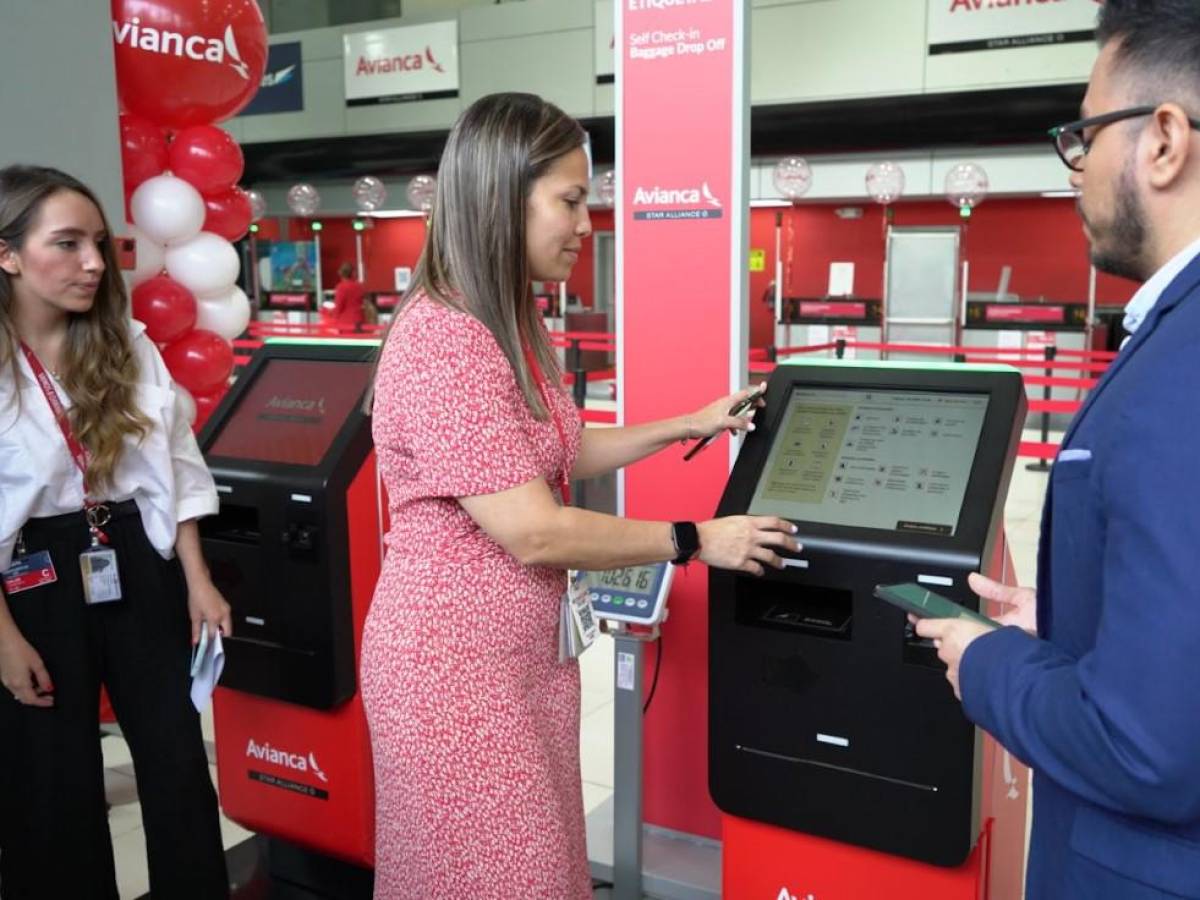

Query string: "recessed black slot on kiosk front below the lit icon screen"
[[736, 580, 854, 641]]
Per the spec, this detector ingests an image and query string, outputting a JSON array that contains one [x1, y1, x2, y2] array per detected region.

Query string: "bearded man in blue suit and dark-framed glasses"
[[917, 0, 1200, 900]]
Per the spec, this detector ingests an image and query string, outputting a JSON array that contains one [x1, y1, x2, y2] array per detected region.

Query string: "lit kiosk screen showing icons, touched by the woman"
[[749, 386, 988, 536]]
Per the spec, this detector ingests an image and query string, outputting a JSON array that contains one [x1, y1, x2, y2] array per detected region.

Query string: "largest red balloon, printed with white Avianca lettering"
[[112, 0, 266, 128]]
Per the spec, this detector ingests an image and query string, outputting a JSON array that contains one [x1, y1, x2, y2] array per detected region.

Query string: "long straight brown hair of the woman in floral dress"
[[372, 94, 587, 420]]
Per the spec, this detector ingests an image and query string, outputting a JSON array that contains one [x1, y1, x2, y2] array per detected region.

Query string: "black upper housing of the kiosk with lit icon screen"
[[709, 361, 1026, 865]]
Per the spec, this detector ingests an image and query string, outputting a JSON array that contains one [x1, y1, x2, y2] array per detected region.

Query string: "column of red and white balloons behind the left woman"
[[112, 0, 266, 430]]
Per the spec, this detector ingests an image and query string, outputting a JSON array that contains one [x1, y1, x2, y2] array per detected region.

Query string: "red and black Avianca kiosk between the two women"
[[199, 341, 383, 883]]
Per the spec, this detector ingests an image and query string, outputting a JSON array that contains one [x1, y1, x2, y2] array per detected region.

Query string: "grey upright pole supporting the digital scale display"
[[605, 622, 659, 900]]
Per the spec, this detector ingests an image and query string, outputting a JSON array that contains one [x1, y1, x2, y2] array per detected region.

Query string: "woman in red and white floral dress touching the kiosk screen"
[[362, 94, 797, 900]]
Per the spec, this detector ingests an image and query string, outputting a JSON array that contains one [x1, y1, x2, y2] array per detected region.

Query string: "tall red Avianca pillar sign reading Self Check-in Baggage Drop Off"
[[616, 0, 749, 838]]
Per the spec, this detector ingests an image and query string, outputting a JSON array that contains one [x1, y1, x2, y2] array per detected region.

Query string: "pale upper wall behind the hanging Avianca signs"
[[227, 0, 1096, 143]]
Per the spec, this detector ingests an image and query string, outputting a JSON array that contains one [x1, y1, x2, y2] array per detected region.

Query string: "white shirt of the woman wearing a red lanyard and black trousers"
[[0, 322, 218, 570]]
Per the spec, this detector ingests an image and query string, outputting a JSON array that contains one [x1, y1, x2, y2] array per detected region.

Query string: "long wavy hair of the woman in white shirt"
[[0, 166, 151, 493]]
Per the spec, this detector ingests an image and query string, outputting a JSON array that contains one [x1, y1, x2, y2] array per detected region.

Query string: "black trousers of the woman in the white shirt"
[[0, 502, 229, 900]]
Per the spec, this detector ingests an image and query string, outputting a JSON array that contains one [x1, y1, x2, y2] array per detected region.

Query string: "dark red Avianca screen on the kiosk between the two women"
[[209, 359, 371, 466]]
